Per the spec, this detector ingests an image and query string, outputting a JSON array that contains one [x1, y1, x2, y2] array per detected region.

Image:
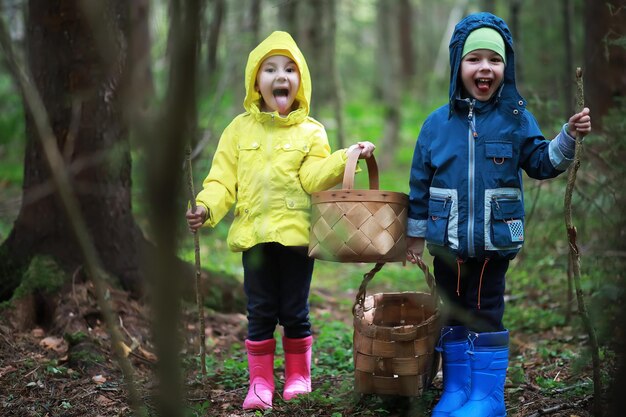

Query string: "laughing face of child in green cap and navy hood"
[[461, 49, 504, 101]]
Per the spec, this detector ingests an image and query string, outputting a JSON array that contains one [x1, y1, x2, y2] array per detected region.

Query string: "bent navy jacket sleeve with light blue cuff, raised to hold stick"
[[520, 112, 572, 180]]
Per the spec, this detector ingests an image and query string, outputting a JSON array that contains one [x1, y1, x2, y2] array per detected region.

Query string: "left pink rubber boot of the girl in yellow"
[[243, 339, 276, 410]]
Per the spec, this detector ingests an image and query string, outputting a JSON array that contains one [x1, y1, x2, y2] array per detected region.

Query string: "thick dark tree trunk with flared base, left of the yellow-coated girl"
[[0, 0, 142, 299]]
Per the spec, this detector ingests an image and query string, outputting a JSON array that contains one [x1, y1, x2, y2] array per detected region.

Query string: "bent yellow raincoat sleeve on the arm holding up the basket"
[[299, 127, 348, 194]]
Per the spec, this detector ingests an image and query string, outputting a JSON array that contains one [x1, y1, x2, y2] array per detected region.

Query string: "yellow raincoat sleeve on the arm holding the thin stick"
[[196, 119, 239, 227]]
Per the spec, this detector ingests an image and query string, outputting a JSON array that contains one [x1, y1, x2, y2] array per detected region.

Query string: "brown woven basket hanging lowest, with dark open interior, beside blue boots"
[[353, 264, 440, 396]]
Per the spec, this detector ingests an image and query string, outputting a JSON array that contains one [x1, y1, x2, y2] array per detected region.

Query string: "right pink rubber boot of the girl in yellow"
[[283, 336, 313, 401]]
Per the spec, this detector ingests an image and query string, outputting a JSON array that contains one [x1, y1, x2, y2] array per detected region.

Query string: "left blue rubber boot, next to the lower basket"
[[432, 326, 471, 417]]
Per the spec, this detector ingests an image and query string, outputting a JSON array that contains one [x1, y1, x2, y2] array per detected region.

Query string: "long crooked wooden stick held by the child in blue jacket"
[[564, 68, 602, 417]]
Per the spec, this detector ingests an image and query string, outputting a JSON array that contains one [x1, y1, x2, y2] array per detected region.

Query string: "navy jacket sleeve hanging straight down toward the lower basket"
[[407, 119, 433, 237]]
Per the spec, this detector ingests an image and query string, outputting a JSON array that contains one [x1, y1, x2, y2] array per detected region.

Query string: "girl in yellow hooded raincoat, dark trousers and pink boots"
[[186, 32, 374, 409]]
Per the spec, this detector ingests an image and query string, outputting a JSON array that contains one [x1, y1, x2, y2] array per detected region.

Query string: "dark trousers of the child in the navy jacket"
[[433, 256, 509, 333]]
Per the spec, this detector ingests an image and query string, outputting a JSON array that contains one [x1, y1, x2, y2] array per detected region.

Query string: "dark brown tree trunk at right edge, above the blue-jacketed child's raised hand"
[[583, 0, 626, 131]]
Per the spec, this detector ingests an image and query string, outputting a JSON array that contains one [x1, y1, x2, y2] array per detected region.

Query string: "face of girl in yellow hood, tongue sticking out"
[[255, 55, 300, 116]]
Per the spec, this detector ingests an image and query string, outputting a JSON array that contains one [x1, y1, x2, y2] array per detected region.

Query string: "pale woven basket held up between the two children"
[[309, 149, 409, 262]]
